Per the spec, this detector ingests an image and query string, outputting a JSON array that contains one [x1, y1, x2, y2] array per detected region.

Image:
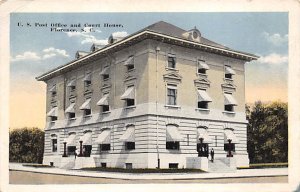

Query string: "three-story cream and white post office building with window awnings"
[[37, 21, 257, 168]]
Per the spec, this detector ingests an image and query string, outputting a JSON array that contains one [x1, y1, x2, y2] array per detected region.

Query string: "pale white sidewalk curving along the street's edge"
[[9, 163, 288, 180]]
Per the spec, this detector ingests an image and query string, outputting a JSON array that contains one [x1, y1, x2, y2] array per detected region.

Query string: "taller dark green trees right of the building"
[[246, 101, 288, 163]]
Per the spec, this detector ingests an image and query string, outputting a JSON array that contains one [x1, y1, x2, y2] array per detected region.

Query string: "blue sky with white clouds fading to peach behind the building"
[[10, 12, 288, 129]]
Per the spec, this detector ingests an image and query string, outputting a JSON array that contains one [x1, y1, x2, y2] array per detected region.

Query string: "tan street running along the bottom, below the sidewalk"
[[9, 170, 288, 184]]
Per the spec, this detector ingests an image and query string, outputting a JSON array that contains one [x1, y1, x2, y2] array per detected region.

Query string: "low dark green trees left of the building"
[[9, 127, 44, 163]]
